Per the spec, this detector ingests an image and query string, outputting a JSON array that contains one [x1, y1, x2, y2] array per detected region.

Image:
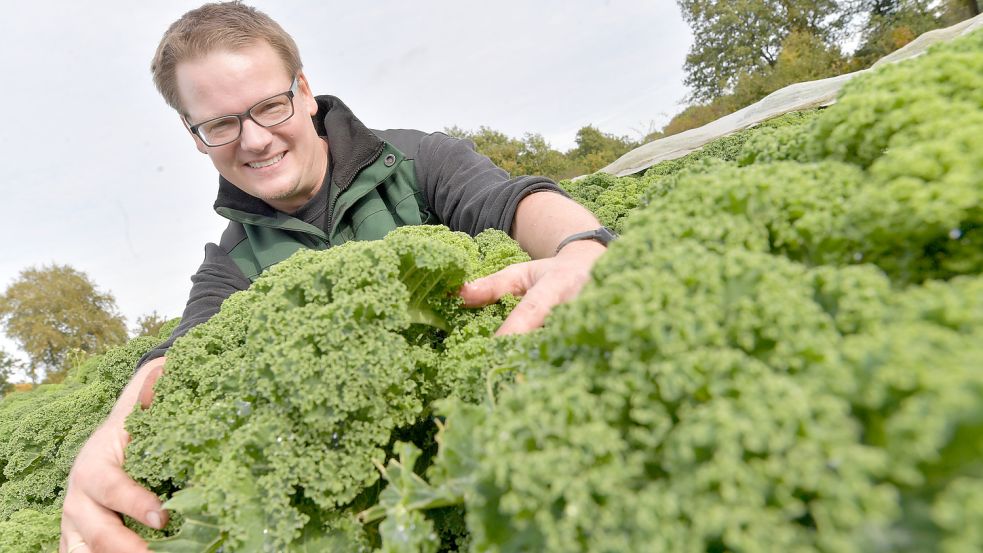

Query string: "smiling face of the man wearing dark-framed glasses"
[[176, 42, 327, 213]]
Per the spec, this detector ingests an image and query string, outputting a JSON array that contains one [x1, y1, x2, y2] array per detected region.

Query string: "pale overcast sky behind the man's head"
[[0, 0, 692, 376]]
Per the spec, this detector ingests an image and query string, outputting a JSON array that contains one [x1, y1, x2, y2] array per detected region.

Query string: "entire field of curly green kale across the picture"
[[0, 31, 983, 553]]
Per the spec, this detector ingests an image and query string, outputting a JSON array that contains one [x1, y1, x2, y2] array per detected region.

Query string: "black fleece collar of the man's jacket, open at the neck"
[[214, 96, 385, 217]]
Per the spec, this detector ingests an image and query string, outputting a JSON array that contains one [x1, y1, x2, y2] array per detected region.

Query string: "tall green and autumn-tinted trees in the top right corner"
[[662, 0, 980, 136]]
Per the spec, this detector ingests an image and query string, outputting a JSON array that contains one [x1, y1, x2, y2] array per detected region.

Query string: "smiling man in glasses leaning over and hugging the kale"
[[61, 3, 607, 553]]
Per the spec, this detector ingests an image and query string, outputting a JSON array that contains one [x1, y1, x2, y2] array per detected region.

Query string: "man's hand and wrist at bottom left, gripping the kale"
[[59, 357, 167, 553]]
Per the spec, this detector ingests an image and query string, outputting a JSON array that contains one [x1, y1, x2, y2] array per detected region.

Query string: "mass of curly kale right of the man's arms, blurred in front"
[[392, 27, 983, 552]]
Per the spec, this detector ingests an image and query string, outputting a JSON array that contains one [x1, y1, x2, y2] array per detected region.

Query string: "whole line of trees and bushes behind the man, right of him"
[[445, 0, 983, 180]]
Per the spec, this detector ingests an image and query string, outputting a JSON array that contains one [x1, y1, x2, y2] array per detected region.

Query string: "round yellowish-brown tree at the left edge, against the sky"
[[0, 265, 126, 383]]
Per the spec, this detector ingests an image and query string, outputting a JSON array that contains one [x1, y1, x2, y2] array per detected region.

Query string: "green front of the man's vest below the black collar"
[[216, 142, 435, 282]]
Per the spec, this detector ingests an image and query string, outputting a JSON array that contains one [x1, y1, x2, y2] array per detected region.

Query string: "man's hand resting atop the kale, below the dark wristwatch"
[[460, 240, 607, 336]]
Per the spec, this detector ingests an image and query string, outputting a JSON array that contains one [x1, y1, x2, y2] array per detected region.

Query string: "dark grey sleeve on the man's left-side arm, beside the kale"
[[137, 243, 249, 368]]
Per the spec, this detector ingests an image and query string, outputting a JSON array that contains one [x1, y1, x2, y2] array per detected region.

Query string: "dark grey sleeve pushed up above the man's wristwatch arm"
[[416, 133, 569, 236]]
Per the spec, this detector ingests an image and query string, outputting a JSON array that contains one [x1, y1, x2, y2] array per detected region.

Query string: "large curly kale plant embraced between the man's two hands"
[[126, 227, 528, 551]]
